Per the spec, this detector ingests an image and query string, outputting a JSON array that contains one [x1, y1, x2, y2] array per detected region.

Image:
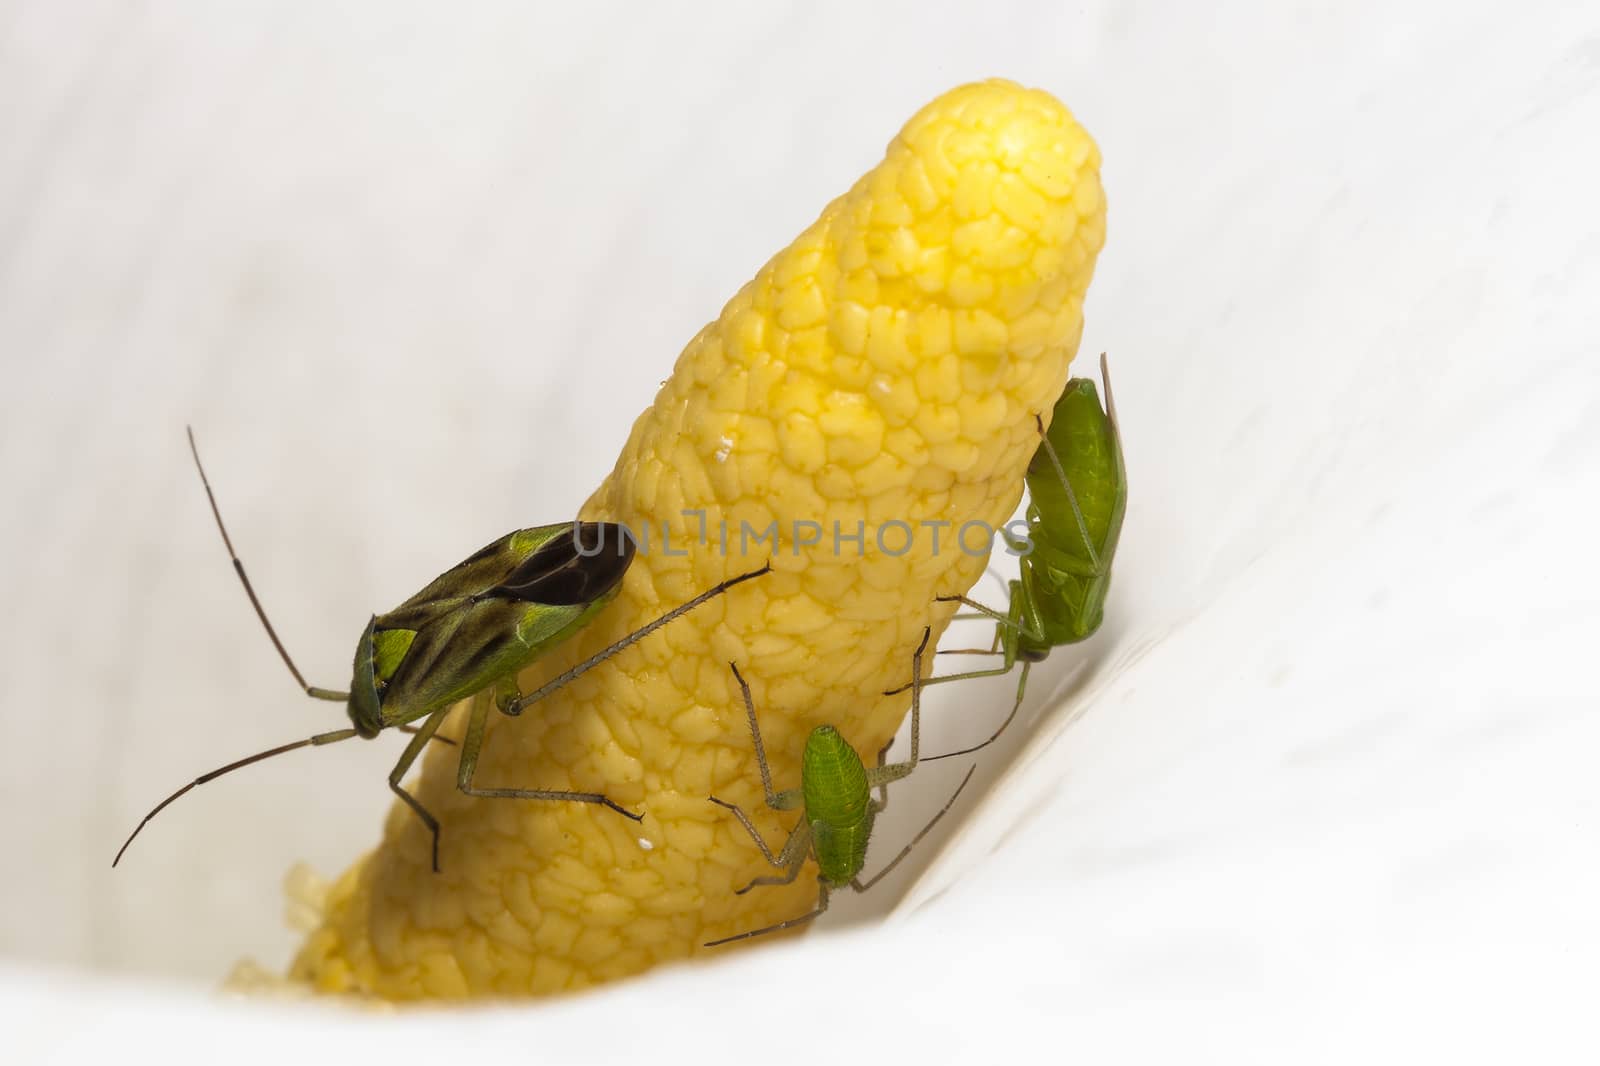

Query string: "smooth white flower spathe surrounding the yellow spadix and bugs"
[[0, 0, 1600, 1063]]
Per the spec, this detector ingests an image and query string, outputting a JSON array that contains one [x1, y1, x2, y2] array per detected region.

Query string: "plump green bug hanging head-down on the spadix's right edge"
[[894, 354, 1128, 762]]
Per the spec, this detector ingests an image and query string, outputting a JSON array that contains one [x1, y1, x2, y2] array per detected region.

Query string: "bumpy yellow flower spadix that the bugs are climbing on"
[[293, 82, 1106, 999]]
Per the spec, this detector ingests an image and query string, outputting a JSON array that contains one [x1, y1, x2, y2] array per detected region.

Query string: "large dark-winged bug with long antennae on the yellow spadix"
[[112, 429, 771, 872]]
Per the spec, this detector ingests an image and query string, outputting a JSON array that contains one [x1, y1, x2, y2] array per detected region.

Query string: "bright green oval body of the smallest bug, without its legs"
[[800, 725, 872, 885]]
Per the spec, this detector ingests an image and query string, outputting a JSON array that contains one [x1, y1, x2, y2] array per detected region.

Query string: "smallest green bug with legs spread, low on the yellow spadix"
[[706, 629, 978, 948]]
